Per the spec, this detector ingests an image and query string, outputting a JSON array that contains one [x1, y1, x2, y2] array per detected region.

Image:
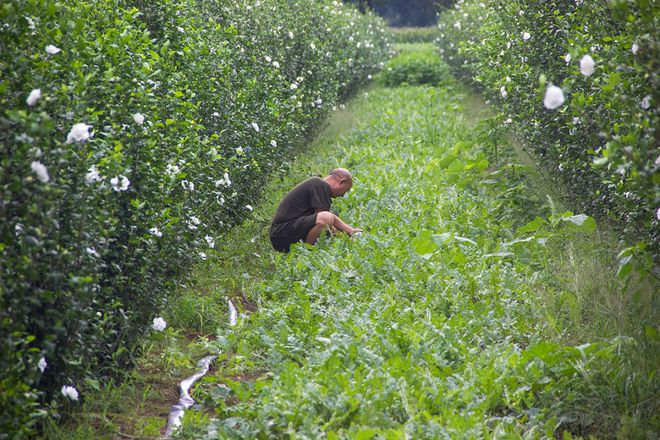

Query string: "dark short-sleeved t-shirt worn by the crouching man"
[[270, 177, 332, 237]]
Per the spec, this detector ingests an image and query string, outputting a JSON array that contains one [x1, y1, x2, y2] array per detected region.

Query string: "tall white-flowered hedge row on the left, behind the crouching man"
[[0, 0, 392, 438]]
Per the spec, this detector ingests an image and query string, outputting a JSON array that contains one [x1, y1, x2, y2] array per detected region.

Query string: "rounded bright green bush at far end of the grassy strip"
[[379, 44, 451, 87]]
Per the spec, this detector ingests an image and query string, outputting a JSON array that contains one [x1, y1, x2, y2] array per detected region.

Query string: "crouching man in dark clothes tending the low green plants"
[[270, 168, 362, 252]]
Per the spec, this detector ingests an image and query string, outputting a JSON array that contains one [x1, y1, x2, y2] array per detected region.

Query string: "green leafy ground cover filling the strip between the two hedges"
[[43, 46, 660, 438]]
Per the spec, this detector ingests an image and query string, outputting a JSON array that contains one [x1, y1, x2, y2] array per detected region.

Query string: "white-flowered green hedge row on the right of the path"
[[439, 0, 660, 252]]
